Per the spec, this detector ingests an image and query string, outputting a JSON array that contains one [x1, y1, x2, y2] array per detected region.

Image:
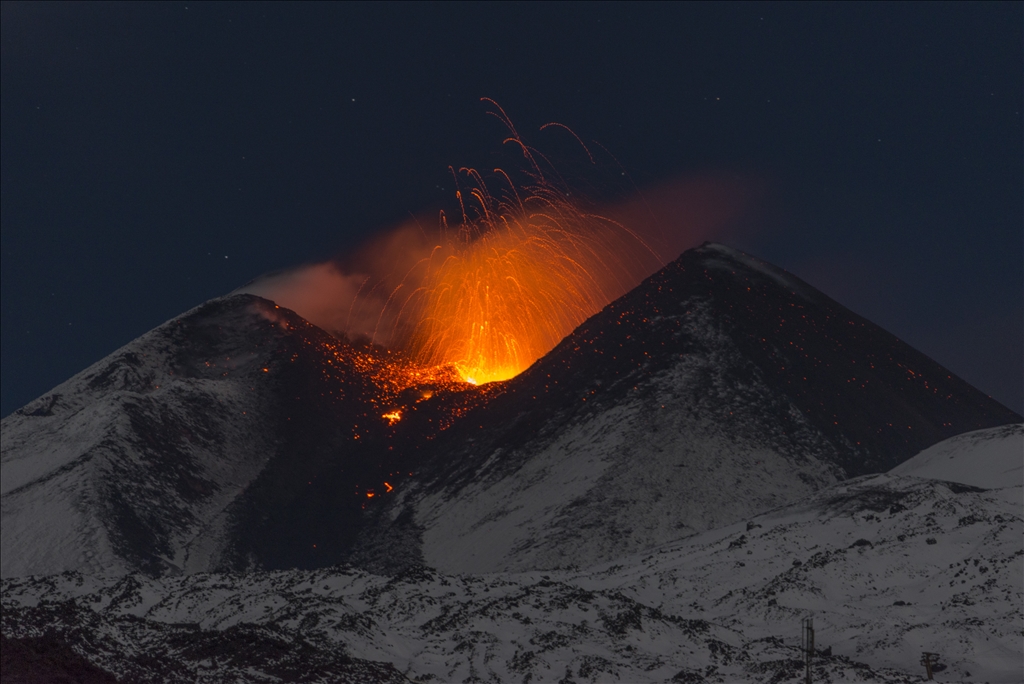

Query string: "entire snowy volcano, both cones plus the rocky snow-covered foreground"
[[0, 244, 1024, 683]]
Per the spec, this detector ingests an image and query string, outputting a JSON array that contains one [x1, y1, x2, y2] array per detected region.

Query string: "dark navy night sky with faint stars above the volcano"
[[0, 2, 1024, 415]]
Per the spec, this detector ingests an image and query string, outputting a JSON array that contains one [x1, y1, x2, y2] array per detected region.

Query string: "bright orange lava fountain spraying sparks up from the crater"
[[381, 100, 659, 384]]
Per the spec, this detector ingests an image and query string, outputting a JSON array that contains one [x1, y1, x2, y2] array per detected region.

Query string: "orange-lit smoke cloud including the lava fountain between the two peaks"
[[241, 113, 750, 382]]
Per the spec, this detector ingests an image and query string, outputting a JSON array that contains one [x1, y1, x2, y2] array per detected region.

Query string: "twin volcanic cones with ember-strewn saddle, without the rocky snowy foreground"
[[2, 244, 1021, 576]]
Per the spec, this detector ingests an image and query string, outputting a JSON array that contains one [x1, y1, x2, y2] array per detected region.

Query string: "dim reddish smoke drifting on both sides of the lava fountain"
[[238, 175, 757, 358]]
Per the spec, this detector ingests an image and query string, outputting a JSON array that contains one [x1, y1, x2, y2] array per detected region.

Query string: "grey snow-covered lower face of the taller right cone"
[[407, 307, 844, 572]]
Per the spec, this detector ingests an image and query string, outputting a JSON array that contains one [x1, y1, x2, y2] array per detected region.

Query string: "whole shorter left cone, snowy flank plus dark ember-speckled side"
[[0, 295, 440, 576]]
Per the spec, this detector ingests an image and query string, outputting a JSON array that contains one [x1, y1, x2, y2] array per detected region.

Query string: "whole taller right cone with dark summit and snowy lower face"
[[364, 245, 1020, 572]]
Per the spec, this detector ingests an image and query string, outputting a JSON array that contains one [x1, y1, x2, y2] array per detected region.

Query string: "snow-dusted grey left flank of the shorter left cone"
[[0, 296, 288, 576]]
